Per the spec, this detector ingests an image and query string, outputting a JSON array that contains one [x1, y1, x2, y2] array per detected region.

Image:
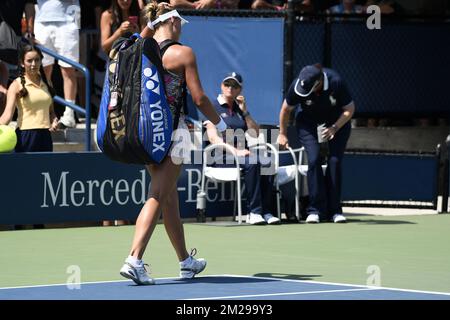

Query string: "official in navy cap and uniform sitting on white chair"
[[205, 72, 280, 224]]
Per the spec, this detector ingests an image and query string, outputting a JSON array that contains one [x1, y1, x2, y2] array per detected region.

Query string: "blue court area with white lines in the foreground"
[[0, 275, 450, 300]]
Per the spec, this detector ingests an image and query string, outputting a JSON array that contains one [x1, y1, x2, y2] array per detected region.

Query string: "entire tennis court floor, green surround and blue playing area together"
[[0, 214, 450, 300]]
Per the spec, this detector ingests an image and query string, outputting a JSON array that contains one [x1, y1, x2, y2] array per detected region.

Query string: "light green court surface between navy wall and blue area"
[[0, 214, 450, 292]]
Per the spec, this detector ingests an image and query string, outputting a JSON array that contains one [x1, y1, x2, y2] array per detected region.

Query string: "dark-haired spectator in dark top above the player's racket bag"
[[100, 0, 140, 54]]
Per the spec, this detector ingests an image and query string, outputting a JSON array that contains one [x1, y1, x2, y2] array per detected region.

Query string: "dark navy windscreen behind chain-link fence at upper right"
[[331, 23, 450, 115]]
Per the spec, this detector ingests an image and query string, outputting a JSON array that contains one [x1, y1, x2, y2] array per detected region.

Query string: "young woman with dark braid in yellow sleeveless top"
[[0, 43, 58, 152]]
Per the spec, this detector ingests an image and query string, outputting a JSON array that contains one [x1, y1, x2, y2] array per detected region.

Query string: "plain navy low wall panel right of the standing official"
[[342, 154, 438, 202]]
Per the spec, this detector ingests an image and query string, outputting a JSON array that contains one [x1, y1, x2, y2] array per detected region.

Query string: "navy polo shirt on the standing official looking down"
[[286, 68, 353, 125]]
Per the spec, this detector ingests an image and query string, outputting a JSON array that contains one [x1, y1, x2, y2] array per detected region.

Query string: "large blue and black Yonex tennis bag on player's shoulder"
[[97, 34, 179, 164]]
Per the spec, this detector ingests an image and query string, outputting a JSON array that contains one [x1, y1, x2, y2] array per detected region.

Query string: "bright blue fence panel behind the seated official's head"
[[181, 16, 284, 124]]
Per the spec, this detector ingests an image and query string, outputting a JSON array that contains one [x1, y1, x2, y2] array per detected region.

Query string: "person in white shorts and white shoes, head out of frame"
[[34, 0, 80, 128]]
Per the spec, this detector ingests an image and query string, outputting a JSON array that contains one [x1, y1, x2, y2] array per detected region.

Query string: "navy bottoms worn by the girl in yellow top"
[[15, 129, 53, 152]]
